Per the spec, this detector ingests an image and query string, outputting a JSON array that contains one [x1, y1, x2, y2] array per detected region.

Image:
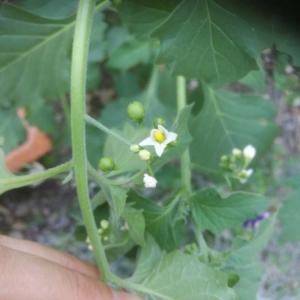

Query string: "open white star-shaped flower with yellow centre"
[[139, 125, 177, 156]]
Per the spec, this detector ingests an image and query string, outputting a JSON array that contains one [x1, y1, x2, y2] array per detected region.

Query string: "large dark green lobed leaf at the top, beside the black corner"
[[151, 0, 270, 85]]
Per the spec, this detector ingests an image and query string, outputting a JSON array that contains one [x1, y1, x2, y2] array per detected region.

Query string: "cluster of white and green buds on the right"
[[220, 145, 256, 183]]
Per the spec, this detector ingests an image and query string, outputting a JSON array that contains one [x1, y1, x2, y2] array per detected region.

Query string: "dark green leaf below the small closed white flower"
[[128, 190, 177, 251]]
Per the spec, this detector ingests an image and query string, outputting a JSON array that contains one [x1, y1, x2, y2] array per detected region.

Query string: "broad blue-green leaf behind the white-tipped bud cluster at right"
[[190, 87, 278, 173]]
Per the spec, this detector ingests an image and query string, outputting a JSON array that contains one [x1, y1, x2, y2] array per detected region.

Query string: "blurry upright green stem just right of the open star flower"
[[177, 76, 192, 195]]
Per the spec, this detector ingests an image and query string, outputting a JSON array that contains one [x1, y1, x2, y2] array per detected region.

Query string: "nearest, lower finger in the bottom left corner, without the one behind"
[[0, 245, 140, 300]]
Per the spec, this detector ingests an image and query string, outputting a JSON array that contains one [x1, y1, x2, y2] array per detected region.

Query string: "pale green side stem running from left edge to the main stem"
[[0, 161, 72, 193]]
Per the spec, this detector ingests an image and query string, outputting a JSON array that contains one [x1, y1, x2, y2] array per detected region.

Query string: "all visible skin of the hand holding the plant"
[[0, 235, 141, 300]]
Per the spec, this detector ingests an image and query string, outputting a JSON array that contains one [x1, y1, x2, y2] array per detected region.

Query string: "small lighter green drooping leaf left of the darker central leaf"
[[122, 206, 145, 247]]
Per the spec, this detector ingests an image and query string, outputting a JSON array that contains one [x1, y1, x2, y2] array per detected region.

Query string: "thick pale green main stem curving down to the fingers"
[[71, 0, 110, 282]]
